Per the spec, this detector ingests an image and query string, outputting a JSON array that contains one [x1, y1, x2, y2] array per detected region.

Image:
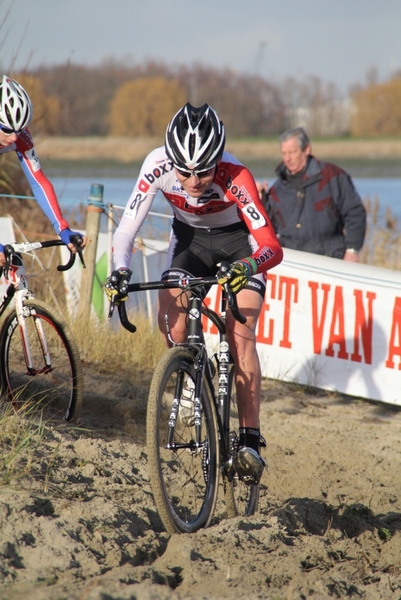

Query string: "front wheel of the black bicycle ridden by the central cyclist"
[[146, 347, 219, 533]]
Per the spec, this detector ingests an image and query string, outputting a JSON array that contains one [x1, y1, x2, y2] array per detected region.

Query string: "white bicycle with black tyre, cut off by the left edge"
[[0, 236, 85, 422]]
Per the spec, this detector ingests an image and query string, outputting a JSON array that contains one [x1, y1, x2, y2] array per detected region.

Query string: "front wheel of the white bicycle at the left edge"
[[0, 300, 83, 422]]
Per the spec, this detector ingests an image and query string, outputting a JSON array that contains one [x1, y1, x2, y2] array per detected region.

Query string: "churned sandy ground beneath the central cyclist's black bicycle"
[[0, 368, 401, 600]]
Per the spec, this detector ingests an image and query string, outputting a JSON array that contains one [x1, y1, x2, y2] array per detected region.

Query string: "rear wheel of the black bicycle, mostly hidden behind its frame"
[[223, 366, 259, 518]]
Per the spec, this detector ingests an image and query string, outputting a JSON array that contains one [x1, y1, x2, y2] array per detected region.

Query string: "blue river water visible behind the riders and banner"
[[52, 177, 401, 231]]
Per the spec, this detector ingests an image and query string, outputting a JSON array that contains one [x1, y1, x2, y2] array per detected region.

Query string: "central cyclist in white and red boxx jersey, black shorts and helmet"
[[105, 103, 283, 483]]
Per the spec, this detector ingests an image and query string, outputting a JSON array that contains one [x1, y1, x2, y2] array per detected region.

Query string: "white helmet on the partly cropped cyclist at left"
[[0, 75, 33, 133]]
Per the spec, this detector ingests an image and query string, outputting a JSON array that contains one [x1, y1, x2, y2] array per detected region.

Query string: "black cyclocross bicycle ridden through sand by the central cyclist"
[[109, 263, 263, 533]]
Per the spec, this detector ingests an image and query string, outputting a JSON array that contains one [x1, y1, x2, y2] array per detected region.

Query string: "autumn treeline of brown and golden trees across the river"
[[7, 60, 401, 137]]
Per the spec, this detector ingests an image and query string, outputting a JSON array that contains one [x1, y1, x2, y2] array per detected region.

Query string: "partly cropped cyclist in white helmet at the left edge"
[[0, 75, 87, 267]]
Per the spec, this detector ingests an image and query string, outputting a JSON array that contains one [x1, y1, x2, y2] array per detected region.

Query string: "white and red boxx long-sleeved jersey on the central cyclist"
[[113, 146, 283, 273]]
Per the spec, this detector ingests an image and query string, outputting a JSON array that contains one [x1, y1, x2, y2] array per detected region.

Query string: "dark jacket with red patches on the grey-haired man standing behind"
[[266, 156, 366, 258]]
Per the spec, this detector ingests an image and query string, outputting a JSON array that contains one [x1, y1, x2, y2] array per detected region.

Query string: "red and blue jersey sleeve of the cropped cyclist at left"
[[0, 129, 69, 233]]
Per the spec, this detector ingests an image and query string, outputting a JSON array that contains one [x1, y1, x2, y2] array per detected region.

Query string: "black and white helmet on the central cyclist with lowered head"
[[165, 102, 226, 172]]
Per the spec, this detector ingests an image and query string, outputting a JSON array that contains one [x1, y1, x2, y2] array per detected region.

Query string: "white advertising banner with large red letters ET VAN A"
[[203, 249, 401, 405]]
